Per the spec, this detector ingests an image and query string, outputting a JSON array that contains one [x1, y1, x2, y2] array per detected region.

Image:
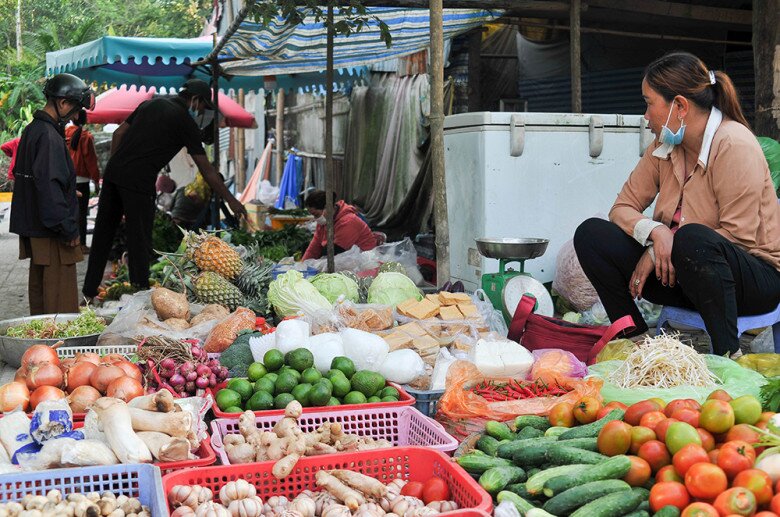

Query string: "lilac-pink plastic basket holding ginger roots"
[[211, 406, 458, 465]]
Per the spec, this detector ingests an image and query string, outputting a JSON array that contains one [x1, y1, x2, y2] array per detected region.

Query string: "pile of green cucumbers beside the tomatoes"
[[457, 409, 651, 517]]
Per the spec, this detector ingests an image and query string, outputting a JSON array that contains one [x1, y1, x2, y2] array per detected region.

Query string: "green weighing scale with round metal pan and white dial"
[[476, 238, 555, 323]]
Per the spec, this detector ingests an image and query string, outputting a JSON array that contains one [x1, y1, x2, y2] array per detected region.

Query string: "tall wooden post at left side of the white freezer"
[[428, 0, 450, 285]]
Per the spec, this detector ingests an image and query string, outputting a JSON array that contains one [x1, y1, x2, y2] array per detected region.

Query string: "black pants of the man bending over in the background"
[[82, 180, 155, 297]]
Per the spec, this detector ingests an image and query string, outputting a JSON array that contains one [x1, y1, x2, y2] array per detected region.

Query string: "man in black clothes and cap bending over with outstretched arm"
[[82, 79, 246, 298]]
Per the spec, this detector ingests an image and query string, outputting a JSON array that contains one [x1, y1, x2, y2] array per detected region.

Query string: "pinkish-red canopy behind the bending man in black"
[[87, 86, 257, 129]]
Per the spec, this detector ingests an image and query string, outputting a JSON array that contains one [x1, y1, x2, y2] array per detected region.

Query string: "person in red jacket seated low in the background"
[[303, 190, 377, 260]]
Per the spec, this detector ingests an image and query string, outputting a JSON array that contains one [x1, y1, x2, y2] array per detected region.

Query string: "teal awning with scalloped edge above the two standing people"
[[46, 36, 367, 91]]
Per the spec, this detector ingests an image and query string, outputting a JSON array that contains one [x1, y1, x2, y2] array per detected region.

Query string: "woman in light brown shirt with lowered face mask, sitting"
[[574, 52, 780, 355]]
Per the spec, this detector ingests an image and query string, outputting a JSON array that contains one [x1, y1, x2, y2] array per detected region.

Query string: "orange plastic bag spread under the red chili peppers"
[[437, 361, 602, 421]]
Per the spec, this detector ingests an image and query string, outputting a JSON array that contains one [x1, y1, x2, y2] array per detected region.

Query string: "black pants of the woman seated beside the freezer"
[[574, 218, 780, 355]]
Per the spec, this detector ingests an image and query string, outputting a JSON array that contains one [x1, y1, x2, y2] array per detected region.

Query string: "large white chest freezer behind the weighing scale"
[[444, 112, 653, 289]]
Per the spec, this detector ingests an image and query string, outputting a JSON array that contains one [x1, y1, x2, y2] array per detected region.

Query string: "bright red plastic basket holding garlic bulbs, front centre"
[[163, 447, 493, 516]]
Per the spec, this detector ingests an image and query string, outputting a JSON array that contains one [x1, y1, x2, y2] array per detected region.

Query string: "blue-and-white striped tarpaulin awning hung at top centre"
[[219, 7, 502, 76]]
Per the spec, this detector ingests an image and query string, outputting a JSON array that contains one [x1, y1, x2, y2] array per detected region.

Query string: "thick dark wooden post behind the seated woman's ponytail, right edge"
[[753, 0, 780, 140]]
